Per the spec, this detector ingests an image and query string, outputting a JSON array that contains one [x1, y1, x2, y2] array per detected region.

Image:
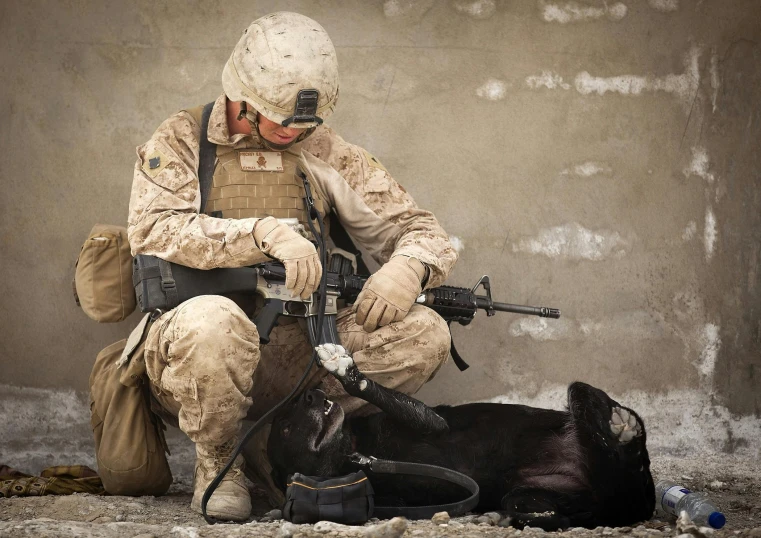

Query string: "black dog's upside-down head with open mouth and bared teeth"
[[267, 389, 351, 490]]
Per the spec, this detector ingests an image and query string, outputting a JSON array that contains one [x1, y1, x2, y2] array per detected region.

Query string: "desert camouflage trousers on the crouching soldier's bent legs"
[[145, 295, 450, 444]]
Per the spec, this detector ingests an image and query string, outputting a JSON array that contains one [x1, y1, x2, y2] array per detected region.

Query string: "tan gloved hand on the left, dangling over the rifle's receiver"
[[254, 217, 322, 299]]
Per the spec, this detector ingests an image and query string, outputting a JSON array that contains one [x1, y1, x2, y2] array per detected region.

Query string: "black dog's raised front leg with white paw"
[[316, 344, 449, 433]]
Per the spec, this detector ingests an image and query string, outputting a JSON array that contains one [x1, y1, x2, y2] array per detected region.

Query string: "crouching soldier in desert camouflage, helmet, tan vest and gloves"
[[128, 12, 457, 520]]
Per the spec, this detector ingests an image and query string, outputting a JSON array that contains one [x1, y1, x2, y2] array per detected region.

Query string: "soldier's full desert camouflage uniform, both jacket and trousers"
[[128, 95, 457, 443]]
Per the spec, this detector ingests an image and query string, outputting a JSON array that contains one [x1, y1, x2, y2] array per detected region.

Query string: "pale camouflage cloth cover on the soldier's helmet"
[[222, 11, 338, 128]]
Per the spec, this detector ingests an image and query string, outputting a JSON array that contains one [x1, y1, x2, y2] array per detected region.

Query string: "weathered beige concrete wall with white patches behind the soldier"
[[0, 0, 761, 458]]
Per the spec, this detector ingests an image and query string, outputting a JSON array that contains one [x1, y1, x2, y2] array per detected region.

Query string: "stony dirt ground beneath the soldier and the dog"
[[0, 455, 761, 538]]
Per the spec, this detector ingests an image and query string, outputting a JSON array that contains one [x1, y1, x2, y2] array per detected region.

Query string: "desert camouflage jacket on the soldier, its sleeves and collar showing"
[[127, 95, 457, 287]]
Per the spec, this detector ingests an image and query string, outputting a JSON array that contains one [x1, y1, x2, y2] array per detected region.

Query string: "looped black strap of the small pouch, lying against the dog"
[[351, 453, 479, 519]]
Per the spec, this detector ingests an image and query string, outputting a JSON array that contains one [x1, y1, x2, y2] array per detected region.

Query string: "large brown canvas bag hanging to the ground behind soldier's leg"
[[90, 326, 172, 496]]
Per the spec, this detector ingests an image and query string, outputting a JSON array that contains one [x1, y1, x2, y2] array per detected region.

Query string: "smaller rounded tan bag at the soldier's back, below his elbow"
[[74, 224, 136, 323]]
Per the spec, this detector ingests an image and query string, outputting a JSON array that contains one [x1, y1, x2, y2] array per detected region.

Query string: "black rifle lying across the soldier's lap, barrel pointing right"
[[132, 254, 560, 370]]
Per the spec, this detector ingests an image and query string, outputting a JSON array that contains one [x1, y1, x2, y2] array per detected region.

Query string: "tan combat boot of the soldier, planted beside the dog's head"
[[190, 438, 251, 521]]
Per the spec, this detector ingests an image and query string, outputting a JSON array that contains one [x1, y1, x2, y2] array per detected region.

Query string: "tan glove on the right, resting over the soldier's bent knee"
[[354, 256, 426, 332]]
